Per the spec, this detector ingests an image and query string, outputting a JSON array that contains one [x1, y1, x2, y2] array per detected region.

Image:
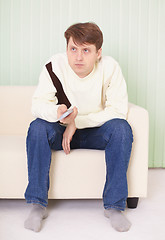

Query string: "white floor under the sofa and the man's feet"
[[0, 169, 165, 240]]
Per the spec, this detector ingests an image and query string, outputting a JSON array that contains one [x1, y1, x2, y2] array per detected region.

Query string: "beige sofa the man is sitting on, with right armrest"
[[0, 86, 149, 208]]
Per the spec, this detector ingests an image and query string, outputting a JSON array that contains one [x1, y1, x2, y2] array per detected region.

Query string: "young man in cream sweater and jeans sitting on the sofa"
[[25, 22, 133, 231]]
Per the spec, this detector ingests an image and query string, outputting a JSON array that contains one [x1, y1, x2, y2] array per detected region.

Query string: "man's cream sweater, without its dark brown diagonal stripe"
[[32, 53, 128, 129]]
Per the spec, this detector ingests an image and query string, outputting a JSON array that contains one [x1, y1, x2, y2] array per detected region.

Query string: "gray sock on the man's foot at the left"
[[24, 204, 48, 232]]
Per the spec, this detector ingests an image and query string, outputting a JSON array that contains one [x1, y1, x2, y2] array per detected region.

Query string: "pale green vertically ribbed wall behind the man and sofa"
[[0, 0, 165, 167]]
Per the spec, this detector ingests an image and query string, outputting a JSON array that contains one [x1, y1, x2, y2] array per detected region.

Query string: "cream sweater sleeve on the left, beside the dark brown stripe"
[[31, 66, 59, 122]]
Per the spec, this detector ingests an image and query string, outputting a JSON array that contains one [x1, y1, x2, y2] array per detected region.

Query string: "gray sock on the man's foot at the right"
[[104, 208, 131, 232]]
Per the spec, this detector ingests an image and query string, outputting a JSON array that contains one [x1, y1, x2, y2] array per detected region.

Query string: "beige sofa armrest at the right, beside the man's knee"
[[127, 103, 149, 197]]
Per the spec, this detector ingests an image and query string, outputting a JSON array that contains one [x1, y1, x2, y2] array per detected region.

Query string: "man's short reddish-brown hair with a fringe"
[[64, 22, 103, 51]]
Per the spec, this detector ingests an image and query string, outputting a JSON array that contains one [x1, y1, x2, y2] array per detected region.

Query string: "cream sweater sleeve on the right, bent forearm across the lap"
[[75, 64, 128, 129]]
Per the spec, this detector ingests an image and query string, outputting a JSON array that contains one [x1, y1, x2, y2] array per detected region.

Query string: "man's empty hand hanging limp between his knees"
[[62, 121, 76, 154]]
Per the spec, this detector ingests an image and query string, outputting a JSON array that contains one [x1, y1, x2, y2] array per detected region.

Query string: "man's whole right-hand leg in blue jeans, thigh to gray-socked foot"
[[80, 119, 133, 231]]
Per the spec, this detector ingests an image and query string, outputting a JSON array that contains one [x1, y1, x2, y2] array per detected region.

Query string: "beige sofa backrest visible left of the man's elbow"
[[0, 86, 36, 135]]
